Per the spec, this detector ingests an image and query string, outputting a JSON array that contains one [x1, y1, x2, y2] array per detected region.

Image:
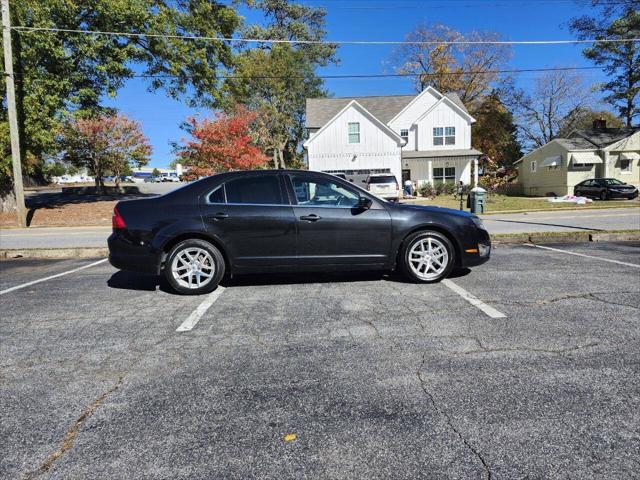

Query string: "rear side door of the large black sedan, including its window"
[[200, 173, 296, 268]]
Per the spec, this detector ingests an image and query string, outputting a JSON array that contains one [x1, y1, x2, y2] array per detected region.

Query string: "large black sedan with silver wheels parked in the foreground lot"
[[109, 170, 491, 294]]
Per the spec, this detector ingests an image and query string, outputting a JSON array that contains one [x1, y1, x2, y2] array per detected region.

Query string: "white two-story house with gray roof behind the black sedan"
[[304, 87, 482, 185]]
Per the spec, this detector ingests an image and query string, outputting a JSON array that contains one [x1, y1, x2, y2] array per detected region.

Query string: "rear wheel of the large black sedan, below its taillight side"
[[163, 238, 225, 295]]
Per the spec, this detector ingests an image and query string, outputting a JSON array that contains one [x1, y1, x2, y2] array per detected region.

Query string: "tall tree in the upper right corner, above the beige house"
[[570, 0, 640, 127]]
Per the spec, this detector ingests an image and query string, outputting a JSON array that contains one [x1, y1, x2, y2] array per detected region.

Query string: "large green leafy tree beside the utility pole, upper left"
[[0, 0, 241, 185]]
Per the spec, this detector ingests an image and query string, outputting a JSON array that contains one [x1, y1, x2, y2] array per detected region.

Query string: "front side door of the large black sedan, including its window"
[[285, 172, 391, 266]]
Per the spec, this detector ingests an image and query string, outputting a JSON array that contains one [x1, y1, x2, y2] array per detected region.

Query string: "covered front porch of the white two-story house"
[[402, 149, 482, 186]]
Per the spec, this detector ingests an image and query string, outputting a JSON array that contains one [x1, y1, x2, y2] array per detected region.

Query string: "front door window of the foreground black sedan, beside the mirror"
[[291, 175, 360, 208]]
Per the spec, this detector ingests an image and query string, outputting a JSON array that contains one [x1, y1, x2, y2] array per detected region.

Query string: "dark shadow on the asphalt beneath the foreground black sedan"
[[102, 268, 471, 294]]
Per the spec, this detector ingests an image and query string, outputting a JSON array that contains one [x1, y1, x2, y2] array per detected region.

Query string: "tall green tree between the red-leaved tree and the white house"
[[225, 0, 336, 168]]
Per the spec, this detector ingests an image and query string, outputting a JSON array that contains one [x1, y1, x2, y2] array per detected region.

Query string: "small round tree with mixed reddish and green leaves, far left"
[[58, 114, 151, 187]]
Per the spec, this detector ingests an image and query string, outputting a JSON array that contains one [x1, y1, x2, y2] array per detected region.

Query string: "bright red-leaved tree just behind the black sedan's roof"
[[178, 107, 268, 179]]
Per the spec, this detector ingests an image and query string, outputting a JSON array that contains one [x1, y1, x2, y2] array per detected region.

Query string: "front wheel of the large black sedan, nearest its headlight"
[[400, 230, 456, 283]]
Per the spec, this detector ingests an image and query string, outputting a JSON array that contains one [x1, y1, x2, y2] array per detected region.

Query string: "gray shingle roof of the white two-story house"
[[306, 93, 469, 128]]
